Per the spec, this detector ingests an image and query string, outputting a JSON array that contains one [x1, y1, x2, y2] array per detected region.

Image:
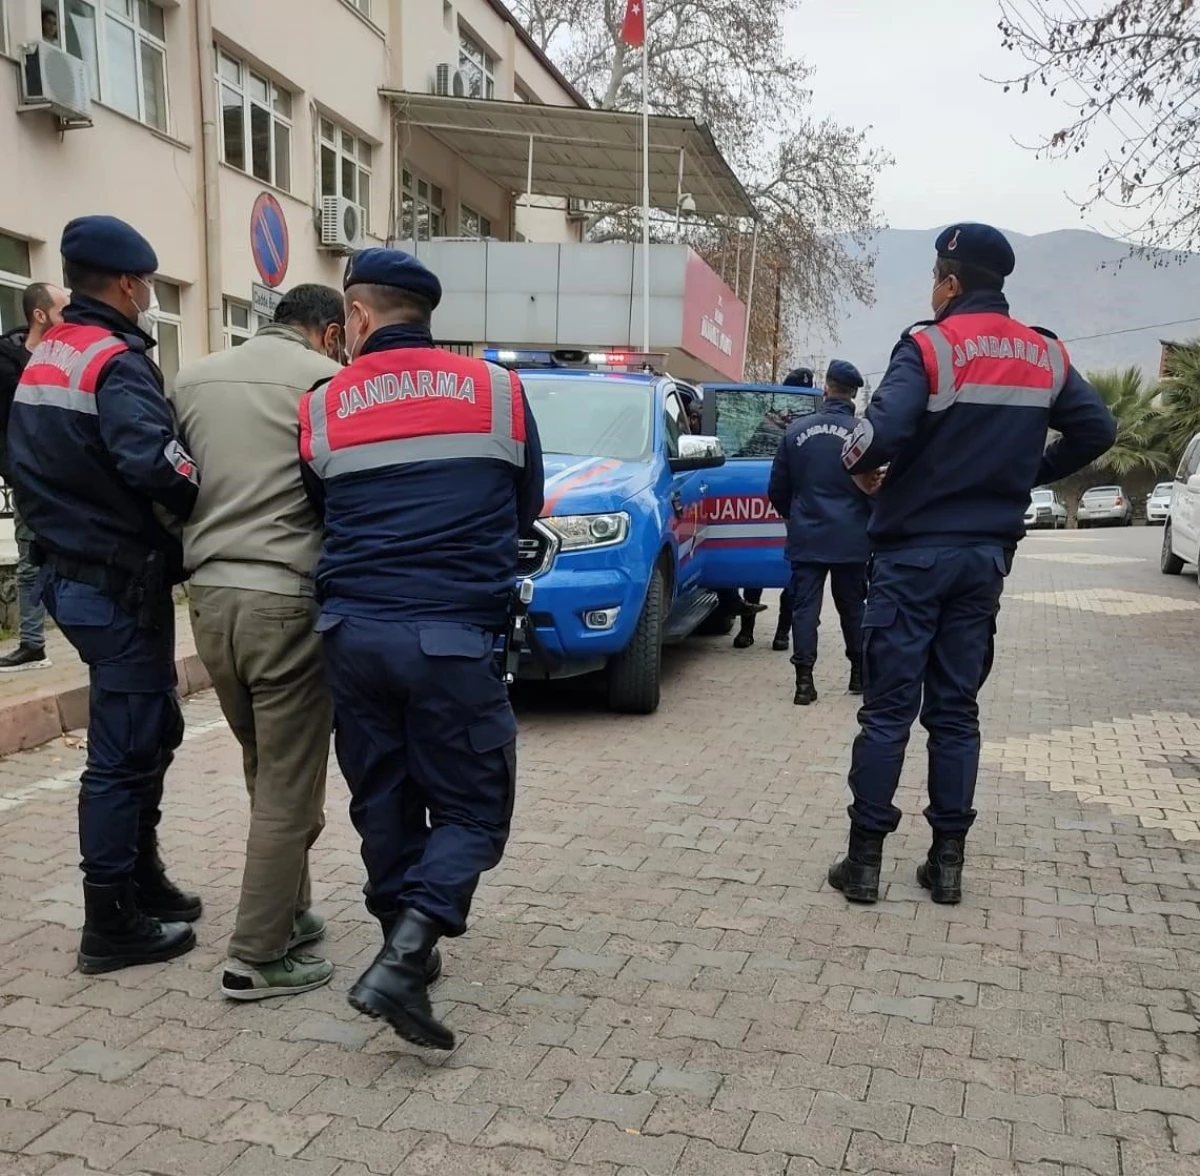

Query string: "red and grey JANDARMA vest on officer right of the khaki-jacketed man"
[[300, 347, 526, 481]]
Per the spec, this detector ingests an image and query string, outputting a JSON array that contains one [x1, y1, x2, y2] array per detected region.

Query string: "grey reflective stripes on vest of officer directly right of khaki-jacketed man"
[[301, 352, 524, 479]]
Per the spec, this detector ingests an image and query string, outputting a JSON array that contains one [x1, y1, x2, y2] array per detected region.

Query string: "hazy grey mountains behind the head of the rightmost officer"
[[788, 229, 1200, 384]]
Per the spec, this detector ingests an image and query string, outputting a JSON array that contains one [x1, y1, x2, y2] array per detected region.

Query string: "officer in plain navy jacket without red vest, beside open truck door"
[[768, 359, 871, 707]]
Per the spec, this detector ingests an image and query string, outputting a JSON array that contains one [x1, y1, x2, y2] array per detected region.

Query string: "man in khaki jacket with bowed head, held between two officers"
[[168, 286, 344, 1001]]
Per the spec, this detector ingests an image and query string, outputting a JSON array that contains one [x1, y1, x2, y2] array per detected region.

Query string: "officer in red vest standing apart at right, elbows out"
[[829, 223, 1116, 902]]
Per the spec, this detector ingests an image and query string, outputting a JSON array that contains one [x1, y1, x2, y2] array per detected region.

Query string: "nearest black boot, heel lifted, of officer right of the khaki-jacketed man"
[[349, 907, 455, 1050]]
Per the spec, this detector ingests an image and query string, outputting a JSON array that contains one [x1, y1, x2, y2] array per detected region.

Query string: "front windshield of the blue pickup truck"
[[524, 377, 654, 462]]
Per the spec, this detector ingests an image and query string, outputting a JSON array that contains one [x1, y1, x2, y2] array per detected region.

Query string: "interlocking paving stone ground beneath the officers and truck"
[[0, 528, 1200, 1176]]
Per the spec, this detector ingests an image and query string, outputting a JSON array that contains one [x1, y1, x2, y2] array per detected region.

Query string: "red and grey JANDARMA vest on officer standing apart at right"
[[912, 312, 1070, 413]]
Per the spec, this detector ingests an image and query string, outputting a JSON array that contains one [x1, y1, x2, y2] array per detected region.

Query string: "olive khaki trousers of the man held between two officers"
[[188, 586, 334, 964]]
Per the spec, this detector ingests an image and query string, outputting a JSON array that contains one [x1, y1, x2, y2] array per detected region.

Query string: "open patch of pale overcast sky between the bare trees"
[[788, 0, 1121, 234]]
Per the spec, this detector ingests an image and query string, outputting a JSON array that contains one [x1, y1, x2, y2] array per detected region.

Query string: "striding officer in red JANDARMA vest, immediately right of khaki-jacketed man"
[[300, 248, 544, 1049]]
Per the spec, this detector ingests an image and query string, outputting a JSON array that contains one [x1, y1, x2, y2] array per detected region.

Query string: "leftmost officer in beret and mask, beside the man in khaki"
[[8, 216, 202, 972]]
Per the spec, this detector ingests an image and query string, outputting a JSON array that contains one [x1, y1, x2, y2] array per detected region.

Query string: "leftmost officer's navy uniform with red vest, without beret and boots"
[[8, 295, 199, 883]]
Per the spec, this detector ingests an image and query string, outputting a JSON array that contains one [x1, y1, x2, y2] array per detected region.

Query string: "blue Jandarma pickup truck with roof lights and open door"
[[485, 350, 820, 714]]
